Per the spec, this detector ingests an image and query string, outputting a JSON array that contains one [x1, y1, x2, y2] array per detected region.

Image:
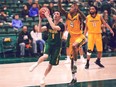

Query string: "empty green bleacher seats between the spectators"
[[0, 0, 93, 57]]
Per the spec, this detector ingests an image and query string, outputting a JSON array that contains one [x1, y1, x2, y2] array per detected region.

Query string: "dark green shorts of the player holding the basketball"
[[44, 43, 61, 65]]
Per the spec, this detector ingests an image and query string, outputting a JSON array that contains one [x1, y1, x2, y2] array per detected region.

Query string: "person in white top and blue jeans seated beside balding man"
[[30, 25, 45, 55]]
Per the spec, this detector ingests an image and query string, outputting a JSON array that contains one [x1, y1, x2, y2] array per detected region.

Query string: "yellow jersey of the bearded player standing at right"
[[86, 14, 102, 33]]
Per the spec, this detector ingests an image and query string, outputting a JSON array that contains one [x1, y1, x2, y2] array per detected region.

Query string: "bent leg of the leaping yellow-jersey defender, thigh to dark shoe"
[[69, 35, 85, 85]]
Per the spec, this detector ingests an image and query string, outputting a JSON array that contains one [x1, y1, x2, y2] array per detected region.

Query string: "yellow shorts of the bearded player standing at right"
[[88, 34, 103, 52]]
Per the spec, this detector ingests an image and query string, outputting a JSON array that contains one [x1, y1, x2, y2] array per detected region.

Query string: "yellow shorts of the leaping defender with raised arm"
[[69, 34, 86, 55]]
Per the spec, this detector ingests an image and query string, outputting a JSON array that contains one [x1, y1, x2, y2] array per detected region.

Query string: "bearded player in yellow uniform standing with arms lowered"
[[84, 6, 114, 69]]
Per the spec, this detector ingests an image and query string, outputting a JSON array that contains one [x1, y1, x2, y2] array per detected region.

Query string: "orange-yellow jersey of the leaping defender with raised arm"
[[66, 13, 82, 36]]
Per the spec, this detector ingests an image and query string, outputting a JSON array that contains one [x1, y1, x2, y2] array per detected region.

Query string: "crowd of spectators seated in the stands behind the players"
[[0, 0, 116, 57]]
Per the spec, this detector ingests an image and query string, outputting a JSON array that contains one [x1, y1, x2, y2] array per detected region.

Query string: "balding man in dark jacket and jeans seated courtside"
[[18, 26, 32, 57]]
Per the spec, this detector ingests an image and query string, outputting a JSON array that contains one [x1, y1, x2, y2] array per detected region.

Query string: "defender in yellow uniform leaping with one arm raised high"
[[58, 0, 86, 85]]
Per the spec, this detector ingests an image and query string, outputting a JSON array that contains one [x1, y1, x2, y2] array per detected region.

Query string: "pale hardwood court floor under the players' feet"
[[0, 57, 116, 87]]
